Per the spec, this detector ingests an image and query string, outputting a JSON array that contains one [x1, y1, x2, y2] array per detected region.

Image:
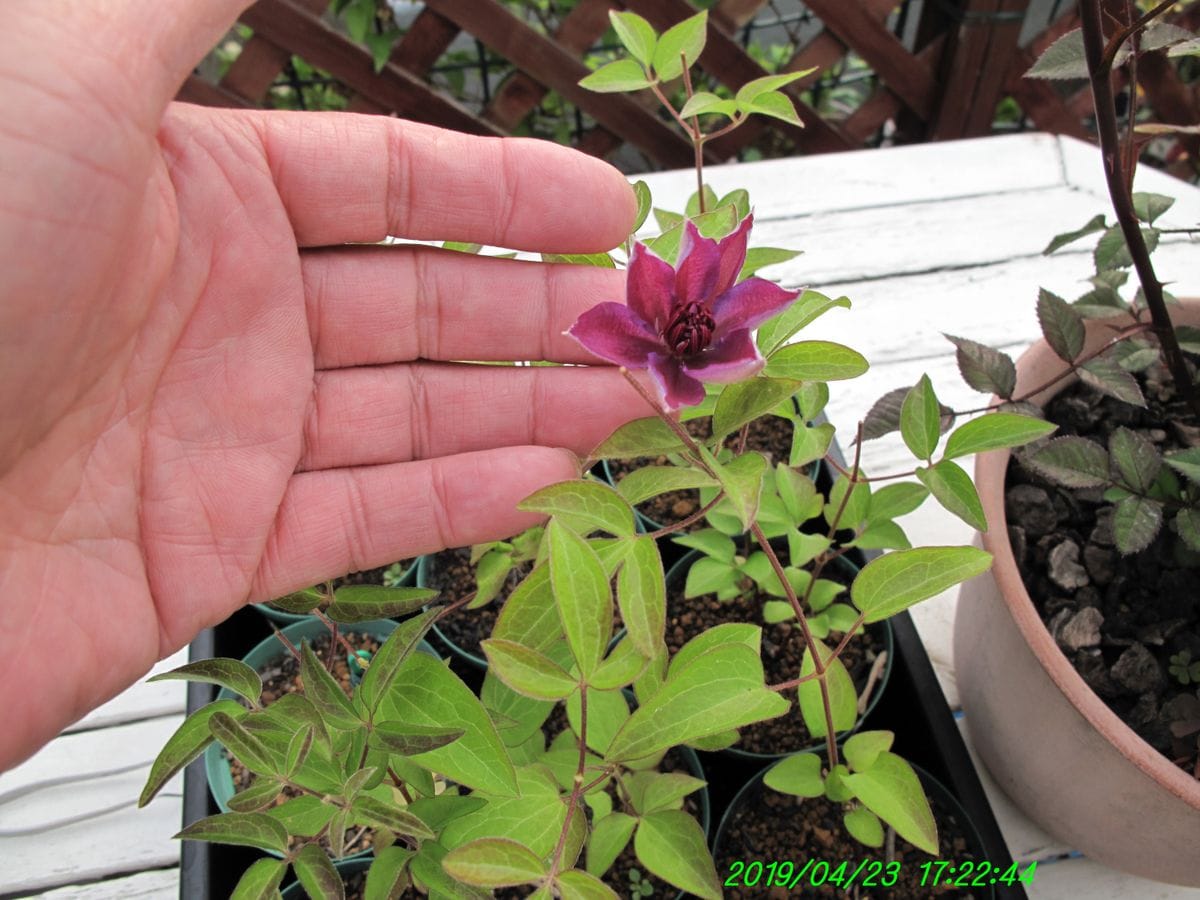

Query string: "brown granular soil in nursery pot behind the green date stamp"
[[715, 784, 986, 900]]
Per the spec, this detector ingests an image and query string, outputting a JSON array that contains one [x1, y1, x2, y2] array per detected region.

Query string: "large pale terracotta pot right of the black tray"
[[954, 300, 1200, 887]]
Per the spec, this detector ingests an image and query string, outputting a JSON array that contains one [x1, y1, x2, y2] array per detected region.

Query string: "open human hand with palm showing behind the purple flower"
[[0, 0, 642, 770]]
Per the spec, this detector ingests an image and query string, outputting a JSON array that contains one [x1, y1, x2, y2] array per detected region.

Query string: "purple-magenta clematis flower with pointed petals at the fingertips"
[[566, 215, 799, 412]]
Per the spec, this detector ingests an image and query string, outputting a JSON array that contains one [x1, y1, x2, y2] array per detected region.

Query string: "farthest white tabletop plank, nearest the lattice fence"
[[638, 134, 1064, 226]]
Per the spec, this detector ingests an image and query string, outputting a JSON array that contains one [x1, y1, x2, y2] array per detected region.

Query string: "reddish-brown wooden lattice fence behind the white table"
[[180, 0, 1200, 174]]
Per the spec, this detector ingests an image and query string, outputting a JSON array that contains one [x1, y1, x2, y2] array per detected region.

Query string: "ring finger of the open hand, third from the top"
[[298, 364, 650, 472]]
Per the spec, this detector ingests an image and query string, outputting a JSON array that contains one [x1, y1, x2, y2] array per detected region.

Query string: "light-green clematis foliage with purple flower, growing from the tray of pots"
[[142, 12, 1050, 898]]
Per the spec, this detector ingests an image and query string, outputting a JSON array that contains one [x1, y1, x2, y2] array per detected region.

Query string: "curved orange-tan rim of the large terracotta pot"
[[974, 300, 1200, 811]]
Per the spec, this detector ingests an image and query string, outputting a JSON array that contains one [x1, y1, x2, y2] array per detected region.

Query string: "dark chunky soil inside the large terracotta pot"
[[1006, 370, 1200, 779]]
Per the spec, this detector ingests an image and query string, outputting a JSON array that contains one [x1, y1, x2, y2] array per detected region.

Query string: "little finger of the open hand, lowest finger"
[[251, 446, 580, 600]]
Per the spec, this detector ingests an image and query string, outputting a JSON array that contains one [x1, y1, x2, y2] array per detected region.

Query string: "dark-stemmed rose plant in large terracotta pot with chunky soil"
[[875, 0, 1200, 886]]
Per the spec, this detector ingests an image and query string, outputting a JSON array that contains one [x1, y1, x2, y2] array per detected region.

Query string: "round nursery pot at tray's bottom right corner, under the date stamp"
[[712, 757, 993, 898]]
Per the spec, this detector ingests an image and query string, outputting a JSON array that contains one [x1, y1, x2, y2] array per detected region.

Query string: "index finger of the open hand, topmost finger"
[[255, 112, 636, 253]]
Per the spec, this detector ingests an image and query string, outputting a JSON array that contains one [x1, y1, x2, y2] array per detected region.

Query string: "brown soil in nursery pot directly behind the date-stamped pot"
[[666, 569, 886, 755]]
